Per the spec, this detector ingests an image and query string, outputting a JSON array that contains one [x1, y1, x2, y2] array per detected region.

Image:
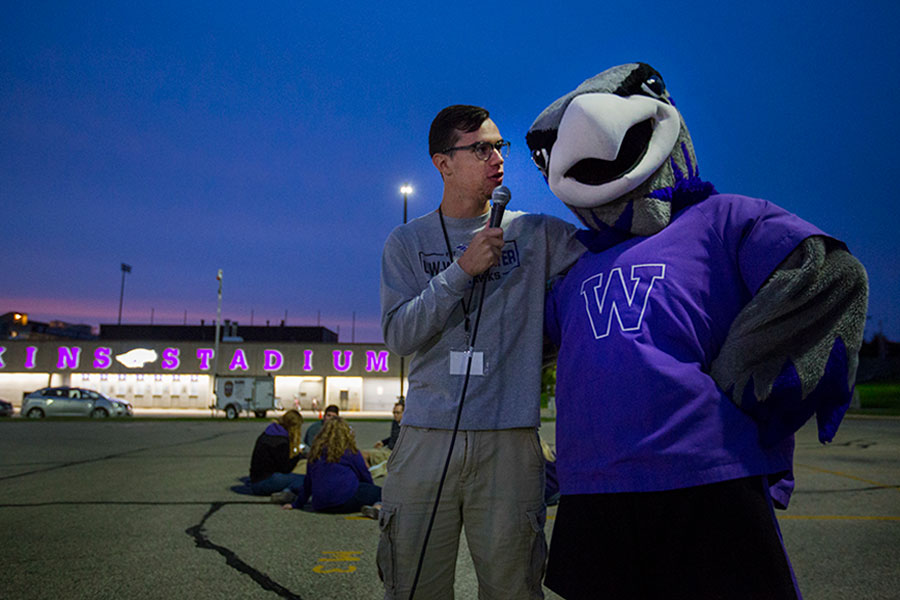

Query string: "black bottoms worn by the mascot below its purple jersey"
[[544, 477, 800, 600]]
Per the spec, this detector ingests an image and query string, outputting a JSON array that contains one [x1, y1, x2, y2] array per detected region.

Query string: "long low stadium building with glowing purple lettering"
[[0, 313, 401, 413]]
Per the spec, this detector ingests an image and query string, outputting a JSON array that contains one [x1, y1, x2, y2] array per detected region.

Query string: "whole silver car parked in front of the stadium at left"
[[19, 387, 133, 419]]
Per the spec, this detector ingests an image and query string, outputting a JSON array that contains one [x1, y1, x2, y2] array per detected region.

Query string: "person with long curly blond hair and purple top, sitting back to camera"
[[283, 417, 381, 513]]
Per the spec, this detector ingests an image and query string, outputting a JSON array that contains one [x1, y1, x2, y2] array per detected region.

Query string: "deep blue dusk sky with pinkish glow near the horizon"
[[0, 0, 900, 342]]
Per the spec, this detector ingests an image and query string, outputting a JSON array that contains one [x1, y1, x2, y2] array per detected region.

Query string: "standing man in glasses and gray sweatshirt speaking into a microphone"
[[378, 105, 584, 600]]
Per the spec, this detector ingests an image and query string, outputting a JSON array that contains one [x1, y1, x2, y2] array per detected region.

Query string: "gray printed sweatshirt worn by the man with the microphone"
[[381, 211, 584, 430]]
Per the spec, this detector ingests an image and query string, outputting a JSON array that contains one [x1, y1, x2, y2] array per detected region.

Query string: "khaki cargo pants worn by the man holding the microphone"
[[378, 426, 547, 600]]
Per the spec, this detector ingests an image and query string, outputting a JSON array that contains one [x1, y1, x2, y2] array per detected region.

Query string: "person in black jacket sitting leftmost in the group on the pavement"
[[250, 409, 303, 496]]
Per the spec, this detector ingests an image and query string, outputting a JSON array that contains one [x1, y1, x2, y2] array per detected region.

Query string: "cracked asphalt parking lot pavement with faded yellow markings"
[[0, 419, 900, 600]]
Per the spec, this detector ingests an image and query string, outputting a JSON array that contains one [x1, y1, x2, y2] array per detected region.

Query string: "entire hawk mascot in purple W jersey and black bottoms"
[[527, 63, 868, 600]]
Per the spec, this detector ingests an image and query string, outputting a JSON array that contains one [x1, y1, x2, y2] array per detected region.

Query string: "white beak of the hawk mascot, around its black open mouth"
[[547, 93, 681, 208]]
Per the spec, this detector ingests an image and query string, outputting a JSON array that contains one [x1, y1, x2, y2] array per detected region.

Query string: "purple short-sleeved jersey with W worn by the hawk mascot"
[[546, 195, 824, 494]]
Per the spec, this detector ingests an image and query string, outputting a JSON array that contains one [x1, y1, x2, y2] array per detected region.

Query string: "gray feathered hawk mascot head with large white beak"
[[526, 63, 715, 235]]
